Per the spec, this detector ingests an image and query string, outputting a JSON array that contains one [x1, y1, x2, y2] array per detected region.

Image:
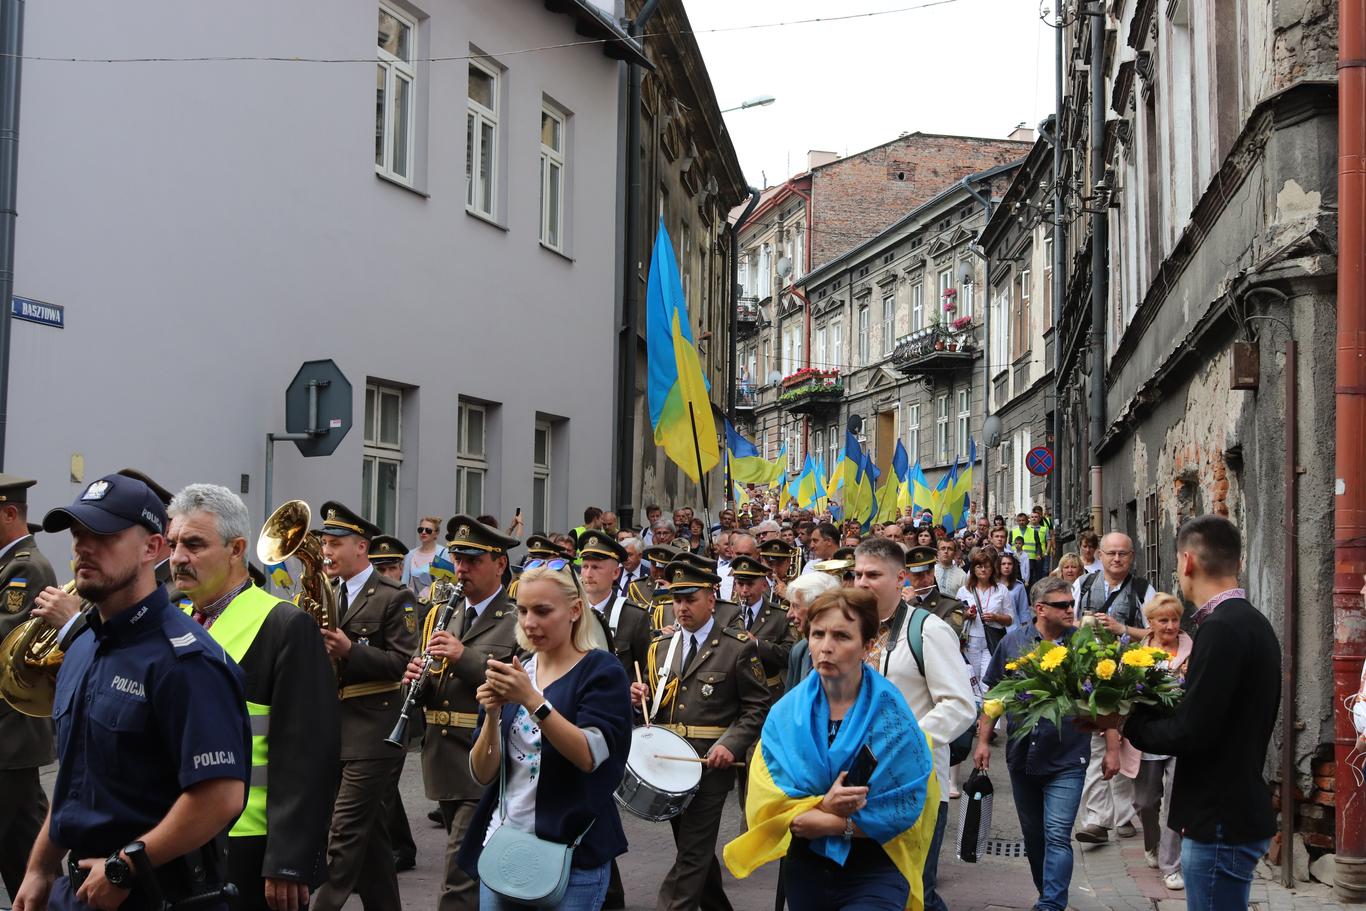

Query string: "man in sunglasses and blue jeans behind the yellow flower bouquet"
[[973, 576, 1091, 911]]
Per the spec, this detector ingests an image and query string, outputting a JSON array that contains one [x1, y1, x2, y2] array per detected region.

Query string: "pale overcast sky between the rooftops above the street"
[[684, 0, 1053, 187]]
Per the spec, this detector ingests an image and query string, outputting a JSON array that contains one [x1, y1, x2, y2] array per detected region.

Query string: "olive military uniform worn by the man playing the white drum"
[[646, 602, 768, 911]]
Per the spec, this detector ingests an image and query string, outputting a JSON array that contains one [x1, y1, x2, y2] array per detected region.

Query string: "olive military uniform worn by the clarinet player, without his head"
[[422, 589, 518, 911]]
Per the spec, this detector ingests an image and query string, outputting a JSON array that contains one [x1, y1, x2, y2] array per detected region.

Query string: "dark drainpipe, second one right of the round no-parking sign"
[[1089, 10, 1109, 534]]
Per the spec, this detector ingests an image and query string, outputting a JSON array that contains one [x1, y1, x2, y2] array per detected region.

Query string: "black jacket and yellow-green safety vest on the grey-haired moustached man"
[[191, 583, 342, 911]]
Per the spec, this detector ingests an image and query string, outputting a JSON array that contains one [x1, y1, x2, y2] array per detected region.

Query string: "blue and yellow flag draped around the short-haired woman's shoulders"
[[723, 668, 940, 911]]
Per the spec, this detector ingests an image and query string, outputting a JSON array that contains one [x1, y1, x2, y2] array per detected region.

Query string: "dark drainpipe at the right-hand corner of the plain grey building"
[[613, 0, 660, 527]]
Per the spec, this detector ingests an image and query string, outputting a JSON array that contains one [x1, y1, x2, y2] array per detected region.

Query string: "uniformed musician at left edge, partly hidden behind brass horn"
[[0, 474, 57, 896]]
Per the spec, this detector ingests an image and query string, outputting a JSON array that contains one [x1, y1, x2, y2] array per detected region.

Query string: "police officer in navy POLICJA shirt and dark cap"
[[15, 474, 251, 911]]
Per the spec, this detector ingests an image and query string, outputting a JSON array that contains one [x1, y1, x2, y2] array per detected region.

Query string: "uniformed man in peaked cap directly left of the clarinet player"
[[313, 501, 417, 911]]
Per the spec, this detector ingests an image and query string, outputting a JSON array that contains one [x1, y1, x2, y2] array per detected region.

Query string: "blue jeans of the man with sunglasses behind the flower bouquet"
[[1011, 768, 1086, 911]]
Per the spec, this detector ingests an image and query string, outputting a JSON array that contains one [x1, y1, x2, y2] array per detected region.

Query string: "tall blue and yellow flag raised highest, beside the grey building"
[[645, 219, 721, 483]]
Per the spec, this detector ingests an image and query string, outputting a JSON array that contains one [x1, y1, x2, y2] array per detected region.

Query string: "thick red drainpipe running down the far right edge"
[[1333, 0, 1366, 901]]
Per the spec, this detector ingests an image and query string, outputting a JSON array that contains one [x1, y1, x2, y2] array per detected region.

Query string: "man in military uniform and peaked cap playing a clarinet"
[[408, 515, 519, 911]]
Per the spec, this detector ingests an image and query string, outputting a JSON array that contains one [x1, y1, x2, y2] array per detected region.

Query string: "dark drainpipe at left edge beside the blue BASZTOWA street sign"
[[0, 0, 23, 468]]
